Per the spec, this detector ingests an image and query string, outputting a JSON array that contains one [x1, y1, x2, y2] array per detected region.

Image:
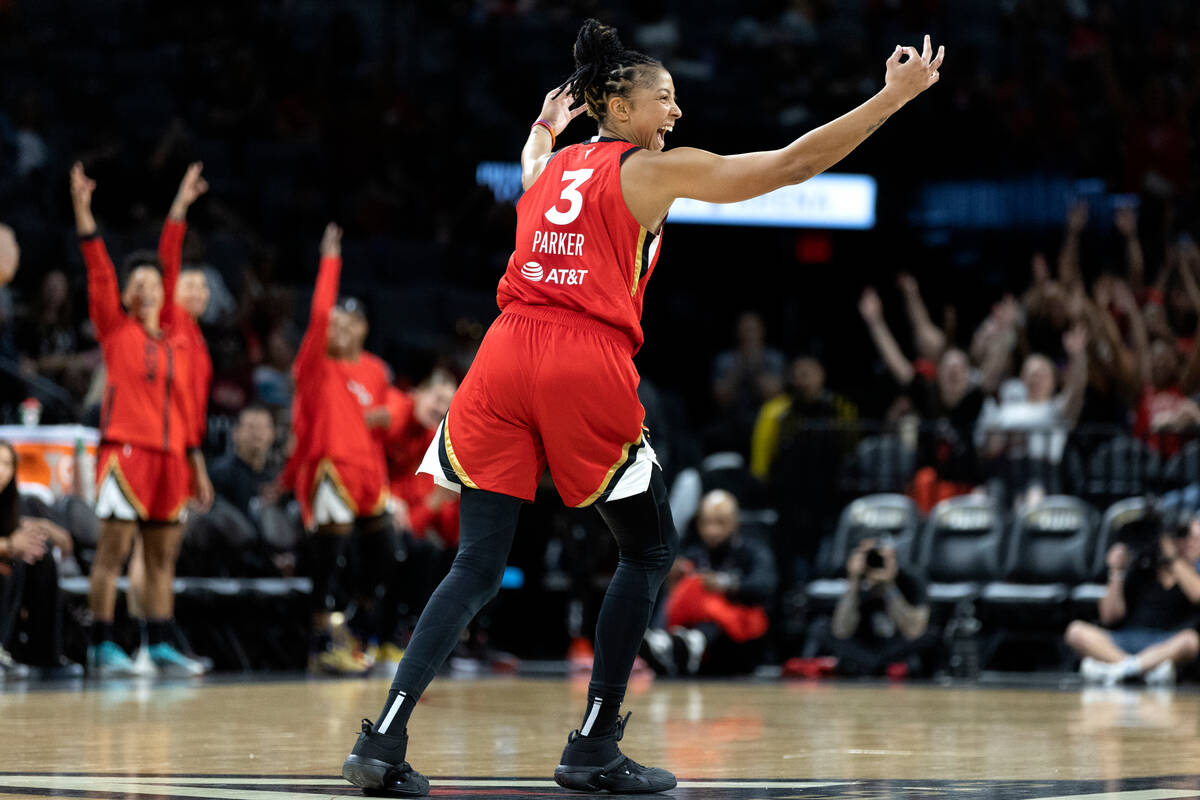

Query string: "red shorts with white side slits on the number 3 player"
[[419, 303, 658, 507]]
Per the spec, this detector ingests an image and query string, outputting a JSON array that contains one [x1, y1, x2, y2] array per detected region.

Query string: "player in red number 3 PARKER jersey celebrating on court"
[[342, 19, 942, 795]]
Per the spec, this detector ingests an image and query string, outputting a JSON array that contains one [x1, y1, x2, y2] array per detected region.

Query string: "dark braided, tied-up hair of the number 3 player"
[[563, 19, 662, 122]]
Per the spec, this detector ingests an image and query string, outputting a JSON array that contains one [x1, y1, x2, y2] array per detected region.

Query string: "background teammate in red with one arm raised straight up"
[[284, 224, 396, 674]]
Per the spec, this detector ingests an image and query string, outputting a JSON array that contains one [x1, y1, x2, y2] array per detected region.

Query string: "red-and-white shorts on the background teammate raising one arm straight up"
[[295, 458, 390, 530]]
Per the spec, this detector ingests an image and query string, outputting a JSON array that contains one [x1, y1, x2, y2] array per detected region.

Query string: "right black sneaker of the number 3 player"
[[554, 714, 676, 794]]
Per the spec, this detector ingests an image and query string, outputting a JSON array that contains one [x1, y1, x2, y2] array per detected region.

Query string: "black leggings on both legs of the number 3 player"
[[378, 467, 679, 733]]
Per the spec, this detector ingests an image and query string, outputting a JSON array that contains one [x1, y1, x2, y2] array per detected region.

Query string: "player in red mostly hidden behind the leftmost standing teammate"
[[126, 162, 212, 675]]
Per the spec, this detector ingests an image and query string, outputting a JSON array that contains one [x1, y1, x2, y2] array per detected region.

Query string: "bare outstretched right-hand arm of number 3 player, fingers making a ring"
[[622, 36, 946, 207]]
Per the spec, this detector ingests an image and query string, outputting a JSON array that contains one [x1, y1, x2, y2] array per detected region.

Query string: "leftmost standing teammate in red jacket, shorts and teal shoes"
[[71, 163, 212, 675]]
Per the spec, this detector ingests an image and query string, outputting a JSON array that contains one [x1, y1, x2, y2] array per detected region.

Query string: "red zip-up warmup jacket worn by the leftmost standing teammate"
[[79, 235, 199, 455]]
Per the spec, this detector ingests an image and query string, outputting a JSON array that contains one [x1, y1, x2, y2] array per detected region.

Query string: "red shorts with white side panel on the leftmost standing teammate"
[[96, 443, 192, 522]]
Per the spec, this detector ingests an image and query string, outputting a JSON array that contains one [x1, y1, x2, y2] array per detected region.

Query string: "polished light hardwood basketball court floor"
[[0, 678, 1200, 800]]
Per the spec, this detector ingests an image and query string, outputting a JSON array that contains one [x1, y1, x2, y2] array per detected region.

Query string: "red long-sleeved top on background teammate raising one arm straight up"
[[283, 257, 391, 489]]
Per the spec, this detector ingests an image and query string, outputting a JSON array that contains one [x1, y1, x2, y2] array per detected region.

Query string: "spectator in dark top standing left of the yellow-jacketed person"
[[708, 311, 787, 452]]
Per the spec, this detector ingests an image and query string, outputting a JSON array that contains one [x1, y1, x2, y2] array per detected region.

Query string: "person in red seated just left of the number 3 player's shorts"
[[384, 368, 458, 549]]
